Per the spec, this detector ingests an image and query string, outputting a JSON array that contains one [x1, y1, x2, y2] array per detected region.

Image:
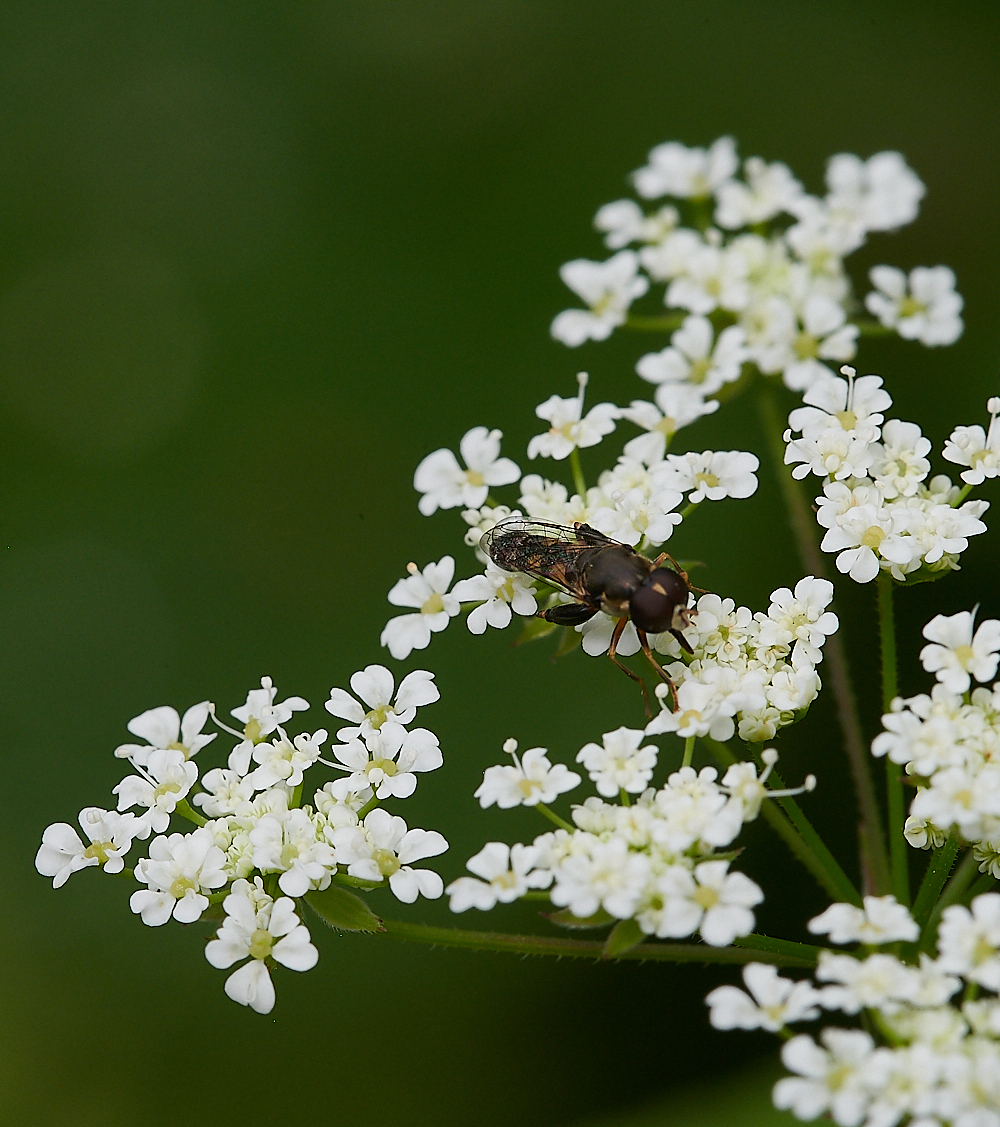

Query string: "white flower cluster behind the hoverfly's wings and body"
[[394, 374, 764, 662]]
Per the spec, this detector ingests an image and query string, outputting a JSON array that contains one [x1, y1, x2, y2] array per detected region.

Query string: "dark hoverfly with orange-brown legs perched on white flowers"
[[479, 517, 696, 712]]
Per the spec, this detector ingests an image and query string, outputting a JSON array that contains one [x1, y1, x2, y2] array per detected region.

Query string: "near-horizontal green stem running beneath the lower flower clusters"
[[382, 920, 818, 967]]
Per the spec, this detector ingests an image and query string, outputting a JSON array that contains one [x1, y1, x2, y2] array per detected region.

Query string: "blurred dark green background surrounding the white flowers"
[[0, 0, 1000, 1127]]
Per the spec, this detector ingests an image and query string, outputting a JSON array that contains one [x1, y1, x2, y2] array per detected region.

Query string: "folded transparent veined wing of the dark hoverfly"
[[479, 517, 618, 602]]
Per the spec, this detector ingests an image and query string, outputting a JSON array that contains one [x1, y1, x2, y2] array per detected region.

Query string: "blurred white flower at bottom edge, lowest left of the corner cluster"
[[773, 1029, 875, 1127]]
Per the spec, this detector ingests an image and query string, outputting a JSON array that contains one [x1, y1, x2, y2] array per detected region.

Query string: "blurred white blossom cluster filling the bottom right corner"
[[706, 893, 1000, 1127]]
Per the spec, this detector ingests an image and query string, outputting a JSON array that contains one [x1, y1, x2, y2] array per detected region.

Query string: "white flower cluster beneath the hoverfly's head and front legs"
[[635, 576, 839, 743]]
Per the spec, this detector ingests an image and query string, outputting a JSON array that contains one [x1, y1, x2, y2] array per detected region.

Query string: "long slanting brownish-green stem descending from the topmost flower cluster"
[[758, 378, 891, 891]]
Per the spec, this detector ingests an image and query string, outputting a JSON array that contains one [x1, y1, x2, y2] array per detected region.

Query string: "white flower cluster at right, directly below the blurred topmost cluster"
[[785, 366, 1000, 583]]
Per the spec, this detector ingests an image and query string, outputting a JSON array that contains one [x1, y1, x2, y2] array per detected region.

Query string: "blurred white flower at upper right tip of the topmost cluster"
[[826, 152, 927, 231]]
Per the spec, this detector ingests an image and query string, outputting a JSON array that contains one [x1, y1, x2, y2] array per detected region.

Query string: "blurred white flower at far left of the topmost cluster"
[[547, 250, 649, 344]]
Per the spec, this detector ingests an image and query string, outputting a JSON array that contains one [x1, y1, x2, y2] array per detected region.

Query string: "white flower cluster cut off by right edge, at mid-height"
[[871, 611, 1000, 861]]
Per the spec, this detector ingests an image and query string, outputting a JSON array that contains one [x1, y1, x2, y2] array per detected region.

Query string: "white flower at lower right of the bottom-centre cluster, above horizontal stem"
[[639, 861, 764, 947]]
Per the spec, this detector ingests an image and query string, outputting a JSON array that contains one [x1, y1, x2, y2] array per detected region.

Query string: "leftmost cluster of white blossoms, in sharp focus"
[[35, 665, 448, 1013]]
